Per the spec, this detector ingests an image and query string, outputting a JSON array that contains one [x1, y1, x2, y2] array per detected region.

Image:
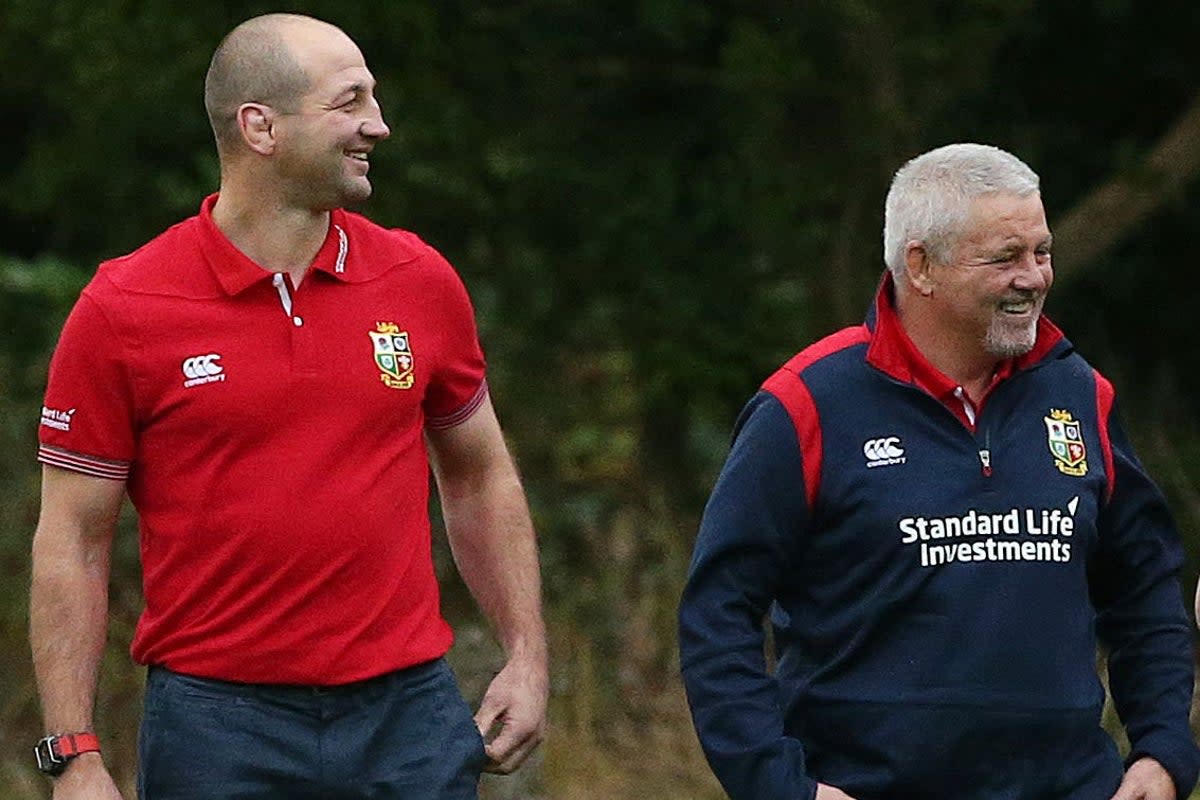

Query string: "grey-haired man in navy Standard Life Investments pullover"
[[679, 144, 1200, 800]]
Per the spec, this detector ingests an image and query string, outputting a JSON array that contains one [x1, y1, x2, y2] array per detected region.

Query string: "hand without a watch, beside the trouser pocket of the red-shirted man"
[[475, 658, 549, 772]]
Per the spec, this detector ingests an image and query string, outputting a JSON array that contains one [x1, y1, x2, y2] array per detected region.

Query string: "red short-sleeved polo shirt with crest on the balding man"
[[38, 196, 487, 685]]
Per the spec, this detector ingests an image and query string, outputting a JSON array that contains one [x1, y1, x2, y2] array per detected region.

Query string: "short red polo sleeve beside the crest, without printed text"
[[424, 254, 487, 429]]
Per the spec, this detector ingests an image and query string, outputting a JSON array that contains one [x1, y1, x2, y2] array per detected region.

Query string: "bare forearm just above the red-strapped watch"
[[29, 528, 109, 733]]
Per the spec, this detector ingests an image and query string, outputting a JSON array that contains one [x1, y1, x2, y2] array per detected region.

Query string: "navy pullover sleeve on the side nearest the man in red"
[[679, 395, 816, 800]]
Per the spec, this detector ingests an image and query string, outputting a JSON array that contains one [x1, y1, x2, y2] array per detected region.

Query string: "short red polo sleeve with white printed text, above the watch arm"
[[37, 290, 134, 481]]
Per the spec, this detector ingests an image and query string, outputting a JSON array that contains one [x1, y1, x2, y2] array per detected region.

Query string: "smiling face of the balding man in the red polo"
[[272, 24, 390, 210]]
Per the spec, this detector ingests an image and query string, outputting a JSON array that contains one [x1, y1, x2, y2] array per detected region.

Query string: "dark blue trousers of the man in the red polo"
[[138, 658, 486, 800]]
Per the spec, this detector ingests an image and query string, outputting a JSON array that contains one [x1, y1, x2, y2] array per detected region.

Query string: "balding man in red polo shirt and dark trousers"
[[30, 14, 548, 800]]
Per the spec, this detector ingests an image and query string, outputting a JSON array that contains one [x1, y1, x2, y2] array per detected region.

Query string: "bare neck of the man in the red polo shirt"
[[212, 180, 329, 285]]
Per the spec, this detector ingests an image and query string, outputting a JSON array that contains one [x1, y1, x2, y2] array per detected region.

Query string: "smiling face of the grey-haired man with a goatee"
[[929, 193, 1054, 359]]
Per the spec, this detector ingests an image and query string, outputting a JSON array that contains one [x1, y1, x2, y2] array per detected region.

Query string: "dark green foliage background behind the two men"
[[7, 0, 1200, 798]]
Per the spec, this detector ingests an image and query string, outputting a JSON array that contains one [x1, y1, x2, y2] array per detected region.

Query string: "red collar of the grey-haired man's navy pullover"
[[866, 270, 1069, 404]]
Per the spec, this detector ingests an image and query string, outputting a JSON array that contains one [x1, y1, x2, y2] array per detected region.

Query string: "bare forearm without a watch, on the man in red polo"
[[442, 462, 546, 662]]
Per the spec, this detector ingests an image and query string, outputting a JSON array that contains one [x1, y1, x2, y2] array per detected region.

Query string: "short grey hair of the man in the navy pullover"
[[883, 144, 1040, 277]]
